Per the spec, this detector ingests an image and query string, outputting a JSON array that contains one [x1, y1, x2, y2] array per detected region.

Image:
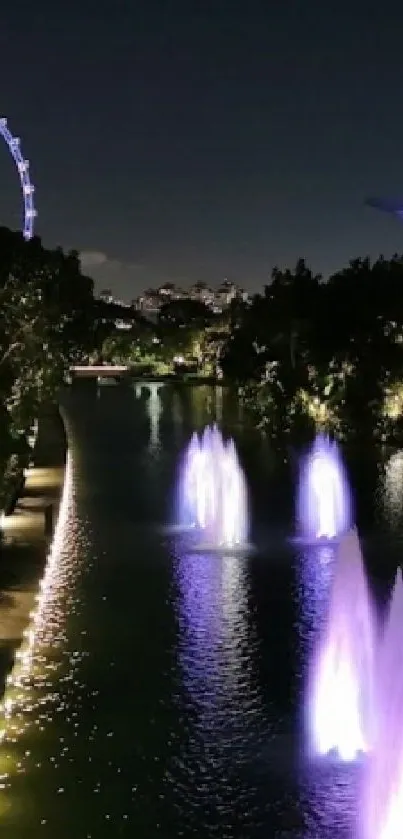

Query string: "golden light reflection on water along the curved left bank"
[[0, 452, 75, 790]]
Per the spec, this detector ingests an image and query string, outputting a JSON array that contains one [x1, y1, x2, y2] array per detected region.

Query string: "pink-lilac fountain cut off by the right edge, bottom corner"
[[359, 570, 403, 839]]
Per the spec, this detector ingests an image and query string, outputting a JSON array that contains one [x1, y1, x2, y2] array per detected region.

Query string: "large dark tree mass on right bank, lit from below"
[[221, 256, 403, 440]]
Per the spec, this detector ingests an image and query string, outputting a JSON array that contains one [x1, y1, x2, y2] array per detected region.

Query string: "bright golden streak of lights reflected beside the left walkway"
[[0, 450, 73, 781]]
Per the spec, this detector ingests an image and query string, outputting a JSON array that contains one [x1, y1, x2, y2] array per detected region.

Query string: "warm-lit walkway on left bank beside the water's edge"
[[0, 405, 67, 696]]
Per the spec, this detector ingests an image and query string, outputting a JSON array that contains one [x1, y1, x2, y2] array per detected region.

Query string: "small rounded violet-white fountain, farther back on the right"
[[297, 434, 351, 541]]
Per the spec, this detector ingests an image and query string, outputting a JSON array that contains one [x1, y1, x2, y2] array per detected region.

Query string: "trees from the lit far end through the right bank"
[[100, 256, 403, 441]]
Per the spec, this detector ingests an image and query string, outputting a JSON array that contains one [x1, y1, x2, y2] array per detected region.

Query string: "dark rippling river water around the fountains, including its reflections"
[[0, 387, 403, 839]]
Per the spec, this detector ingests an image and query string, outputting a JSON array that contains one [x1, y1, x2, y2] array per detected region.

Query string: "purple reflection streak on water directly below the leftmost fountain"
[[177, 540, 263, 746]]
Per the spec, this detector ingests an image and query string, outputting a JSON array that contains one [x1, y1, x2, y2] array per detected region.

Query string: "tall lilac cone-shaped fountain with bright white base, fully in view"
[[307, 528, 380, 764]]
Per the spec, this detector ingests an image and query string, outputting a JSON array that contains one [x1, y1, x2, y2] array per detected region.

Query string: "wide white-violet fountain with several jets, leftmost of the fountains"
[[179, 426, 248, 550]]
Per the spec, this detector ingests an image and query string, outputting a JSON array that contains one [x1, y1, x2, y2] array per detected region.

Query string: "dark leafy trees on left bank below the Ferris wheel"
[[0, 228, 94, 507]]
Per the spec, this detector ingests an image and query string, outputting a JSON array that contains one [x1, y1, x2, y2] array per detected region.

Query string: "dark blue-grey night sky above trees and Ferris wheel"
[[0, 0, 403, 299]]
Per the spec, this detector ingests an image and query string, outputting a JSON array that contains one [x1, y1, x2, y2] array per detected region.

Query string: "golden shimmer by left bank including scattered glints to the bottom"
[[0, 452, 92, 836]]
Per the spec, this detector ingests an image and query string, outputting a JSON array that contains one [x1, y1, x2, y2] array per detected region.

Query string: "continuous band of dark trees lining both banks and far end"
[[0, 223, 403, 476]]
